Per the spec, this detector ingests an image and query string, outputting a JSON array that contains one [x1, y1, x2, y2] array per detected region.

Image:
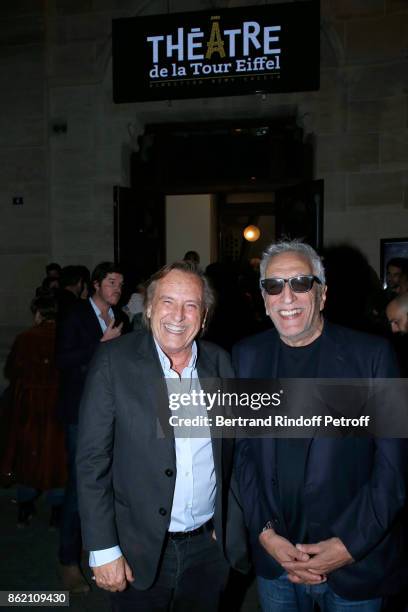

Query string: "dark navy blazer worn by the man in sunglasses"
[[233, 322, 408, 600]]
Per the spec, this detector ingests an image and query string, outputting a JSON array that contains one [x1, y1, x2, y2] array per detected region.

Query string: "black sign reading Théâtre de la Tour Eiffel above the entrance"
[[112, 0, 320, 102]]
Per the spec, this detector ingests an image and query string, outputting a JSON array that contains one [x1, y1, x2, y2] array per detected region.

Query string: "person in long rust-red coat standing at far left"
[[2, 297, 67, 528]]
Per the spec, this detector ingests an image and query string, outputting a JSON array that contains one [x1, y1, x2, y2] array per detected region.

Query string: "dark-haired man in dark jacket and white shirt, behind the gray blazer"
[[56, 262, 130, 593]]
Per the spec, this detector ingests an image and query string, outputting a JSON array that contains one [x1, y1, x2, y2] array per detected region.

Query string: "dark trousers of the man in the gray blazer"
[[111, 532, 229, 612]]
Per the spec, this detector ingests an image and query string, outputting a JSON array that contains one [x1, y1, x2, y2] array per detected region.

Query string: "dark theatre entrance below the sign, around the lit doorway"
[[115, 117, 323, 276]]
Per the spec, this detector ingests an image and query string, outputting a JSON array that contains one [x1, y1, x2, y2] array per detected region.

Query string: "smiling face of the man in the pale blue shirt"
[[146, 270, 205, 361]]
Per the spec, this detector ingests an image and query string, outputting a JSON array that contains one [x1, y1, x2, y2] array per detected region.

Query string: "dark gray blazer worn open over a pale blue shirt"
[[77, 331, 248, 589]]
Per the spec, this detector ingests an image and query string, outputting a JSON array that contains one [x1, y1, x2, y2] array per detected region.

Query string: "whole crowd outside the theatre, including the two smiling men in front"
[[1, 241, 408, 612]]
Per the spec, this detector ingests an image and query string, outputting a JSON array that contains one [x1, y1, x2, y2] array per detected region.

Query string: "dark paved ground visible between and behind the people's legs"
[[0, 489, 258, 612]]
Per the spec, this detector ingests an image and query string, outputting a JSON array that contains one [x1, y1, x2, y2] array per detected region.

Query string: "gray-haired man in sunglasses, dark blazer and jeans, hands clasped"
[[233, 241, 408, 612]]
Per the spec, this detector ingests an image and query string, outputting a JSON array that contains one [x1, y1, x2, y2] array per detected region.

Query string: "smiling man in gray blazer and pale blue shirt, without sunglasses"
[[77, 262, 246, 612]]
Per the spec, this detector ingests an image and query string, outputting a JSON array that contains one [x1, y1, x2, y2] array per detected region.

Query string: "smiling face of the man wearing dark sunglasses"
[[263, 251, 326, 346]]
